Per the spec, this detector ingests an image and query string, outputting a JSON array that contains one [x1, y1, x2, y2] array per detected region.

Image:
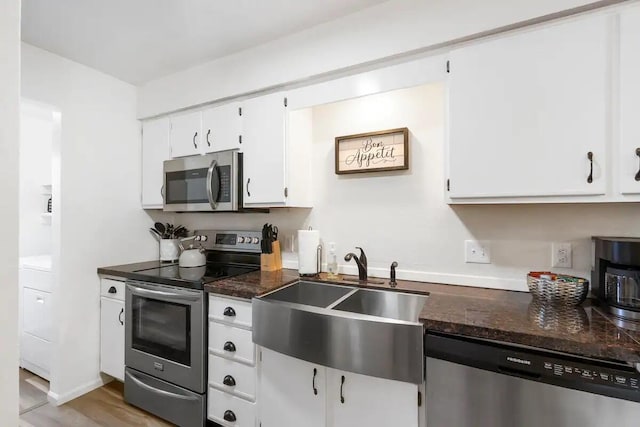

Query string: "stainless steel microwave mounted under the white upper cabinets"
[[162, 150, 242, 212]]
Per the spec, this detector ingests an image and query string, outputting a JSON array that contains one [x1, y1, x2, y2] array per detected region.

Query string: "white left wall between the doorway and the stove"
[[22, 44, 157, 403]]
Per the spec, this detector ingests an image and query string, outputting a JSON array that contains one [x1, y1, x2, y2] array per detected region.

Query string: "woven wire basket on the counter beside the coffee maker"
[[527, 272, 589, 307]]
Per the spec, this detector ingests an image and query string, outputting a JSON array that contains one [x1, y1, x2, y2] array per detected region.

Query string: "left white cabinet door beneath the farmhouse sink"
[[258, 349, 324, 427]]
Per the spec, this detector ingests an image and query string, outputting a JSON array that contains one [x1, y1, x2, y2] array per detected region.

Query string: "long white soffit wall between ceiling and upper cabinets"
[[138, 0, 618, 118]]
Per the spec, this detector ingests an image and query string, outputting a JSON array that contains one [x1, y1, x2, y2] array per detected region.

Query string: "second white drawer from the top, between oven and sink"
[[209, 322, 256, 365]]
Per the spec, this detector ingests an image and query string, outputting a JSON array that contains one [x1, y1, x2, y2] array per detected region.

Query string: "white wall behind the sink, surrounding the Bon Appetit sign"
[[176, 84, 640, 290]]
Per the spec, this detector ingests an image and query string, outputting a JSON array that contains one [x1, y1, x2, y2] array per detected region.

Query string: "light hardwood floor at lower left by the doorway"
[[20, 381, 172, 427]]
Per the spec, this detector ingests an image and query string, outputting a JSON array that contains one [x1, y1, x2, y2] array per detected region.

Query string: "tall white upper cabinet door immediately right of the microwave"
[[242, 93, 286, 205]]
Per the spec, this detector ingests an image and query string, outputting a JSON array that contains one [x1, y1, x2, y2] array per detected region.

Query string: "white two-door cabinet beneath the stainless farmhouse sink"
[[258, 348, 424, 427]]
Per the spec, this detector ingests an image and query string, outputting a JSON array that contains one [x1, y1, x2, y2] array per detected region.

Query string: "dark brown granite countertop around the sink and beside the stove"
[[98, 261, 640, 363]]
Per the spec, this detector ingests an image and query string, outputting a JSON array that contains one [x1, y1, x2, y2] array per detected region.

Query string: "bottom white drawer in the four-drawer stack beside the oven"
[[207, 387, 256, 427]]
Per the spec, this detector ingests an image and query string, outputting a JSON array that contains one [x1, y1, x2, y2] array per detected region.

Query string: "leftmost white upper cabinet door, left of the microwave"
[[142, 117, 171, 209]]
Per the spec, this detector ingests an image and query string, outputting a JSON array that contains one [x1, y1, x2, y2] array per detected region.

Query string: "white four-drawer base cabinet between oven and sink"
[[207, 295, 257, 427]]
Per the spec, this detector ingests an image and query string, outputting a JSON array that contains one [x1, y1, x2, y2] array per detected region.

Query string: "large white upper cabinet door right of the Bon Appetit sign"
[[448, 16, 610, 198]]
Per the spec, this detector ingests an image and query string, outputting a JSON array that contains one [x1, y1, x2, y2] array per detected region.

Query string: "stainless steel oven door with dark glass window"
[[125, 281, 206, 393]]
